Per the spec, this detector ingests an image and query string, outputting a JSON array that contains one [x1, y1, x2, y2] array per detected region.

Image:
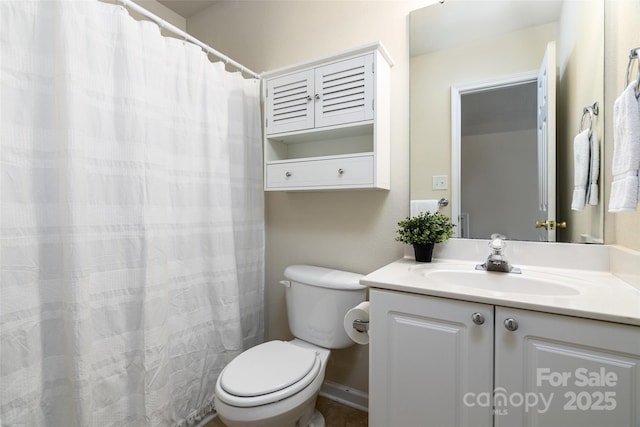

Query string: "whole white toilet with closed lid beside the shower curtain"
[[215, 265, 366, 427]]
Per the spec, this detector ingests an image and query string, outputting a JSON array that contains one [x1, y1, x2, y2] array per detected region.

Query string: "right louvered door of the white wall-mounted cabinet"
[[314, 54, 374, 128]]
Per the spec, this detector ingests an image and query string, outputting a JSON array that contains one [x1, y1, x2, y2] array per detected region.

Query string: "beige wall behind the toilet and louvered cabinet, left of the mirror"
[[187, 0, 424, 392]]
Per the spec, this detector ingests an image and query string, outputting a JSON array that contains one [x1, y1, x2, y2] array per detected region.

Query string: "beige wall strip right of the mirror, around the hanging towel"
[[604, 0, 640, 251]]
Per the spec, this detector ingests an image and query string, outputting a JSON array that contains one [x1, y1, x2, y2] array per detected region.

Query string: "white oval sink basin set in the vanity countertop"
[[417, 266, 580, 296]]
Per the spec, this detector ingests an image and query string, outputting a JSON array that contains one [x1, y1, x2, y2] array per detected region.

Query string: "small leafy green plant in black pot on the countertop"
[[396, 212, 455, 262]]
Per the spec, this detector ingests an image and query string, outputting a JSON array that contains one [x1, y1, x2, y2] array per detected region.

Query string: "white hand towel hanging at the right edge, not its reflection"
[[609, 81, 640, 212]]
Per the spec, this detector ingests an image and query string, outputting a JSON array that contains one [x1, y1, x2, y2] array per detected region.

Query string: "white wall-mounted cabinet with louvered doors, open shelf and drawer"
[[263, 43, 392, 191]]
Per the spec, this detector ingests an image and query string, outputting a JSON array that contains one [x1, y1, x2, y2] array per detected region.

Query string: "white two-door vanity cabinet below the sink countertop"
[[369, 289, 640, 427]]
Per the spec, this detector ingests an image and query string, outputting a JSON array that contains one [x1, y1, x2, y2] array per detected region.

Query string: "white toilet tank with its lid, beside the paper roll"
[[283, 265, 367, 349]]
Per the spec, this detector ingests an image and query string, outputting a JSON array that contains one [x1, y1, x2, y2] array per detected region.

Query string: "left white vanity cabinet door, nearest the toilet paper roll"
[[369, 289, 494, 427]]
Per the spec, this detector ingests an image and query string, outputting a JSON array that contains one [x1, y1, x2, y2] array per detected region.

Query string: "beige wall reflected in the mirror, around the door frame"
[[411, 23, 558, 221]]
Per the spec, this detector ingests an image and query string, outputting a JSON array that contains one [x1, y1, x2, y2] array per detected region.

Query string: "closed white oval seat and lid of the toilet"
[[216, 341, 321, 407]]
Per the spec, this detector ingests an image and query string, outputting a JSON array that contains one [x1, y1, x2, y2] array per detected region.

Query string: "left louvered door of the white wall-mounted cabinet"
[[266, 70, 314, 135]]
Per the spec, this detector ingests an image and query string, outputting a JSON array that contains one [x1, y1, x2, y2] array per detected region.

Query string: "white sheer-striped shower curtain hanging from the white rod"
[[0, 0, 264, 427]]
